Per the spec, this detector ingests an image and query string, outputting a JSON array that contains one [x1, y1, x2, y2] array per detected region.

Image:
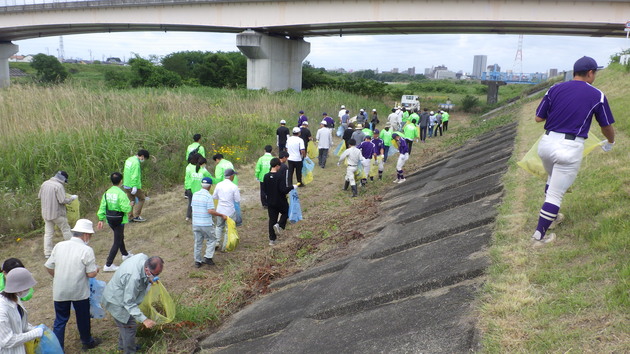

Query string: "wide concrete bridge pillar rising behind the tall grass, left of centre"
[[236, 30, 311, 91]]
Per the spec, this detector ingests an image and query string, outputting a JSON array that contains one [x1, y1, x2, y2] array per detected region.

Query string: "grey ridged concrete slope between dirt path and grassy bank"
[[201, 124, 516, 353]]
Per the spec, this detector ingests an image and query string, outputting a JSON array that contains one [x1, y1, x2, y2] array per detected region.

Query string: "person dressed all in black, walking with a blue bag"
[[263, 158, 297, 246]]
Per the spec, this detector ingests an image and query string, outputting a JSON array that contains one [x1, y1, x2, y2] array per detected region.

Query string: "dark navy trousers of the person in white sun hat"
[[53, 298, 94, 348]]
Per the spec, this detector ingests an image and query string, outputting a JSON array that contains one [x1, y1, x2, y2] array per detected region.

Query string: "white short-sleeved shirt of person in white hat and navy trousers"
[[44, 237, 96, 301]]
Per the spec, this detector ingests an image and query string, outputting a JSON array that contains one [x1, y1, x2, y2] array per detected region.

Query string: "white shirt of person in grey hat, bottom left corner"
[[0, 295, 42, 354]]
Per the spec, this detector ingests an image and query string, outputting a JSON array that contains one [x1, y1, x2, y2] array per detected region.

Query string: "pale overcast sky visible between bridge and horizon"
[[14, 32, 630, 74]]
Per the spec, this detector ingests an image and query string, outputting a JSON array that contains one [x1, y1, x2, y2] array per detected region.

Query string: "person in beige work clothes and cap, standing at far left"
[[37, 171, 78, 258]]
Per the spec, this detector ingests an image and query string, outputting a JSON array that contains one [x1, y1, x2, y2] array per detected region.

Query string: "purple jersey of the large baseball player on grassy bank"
[[536, 80, 615, 138]]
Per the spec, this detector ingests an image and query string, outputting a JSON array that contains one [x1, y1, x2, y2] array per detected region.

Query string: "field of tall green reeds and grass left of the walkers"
[[0, 82, 387, 235]]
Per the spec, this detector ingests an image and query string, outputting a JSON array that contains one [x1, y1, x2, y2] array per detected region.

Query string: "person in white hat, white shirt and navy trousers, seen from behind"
[[44, 219, 101, 350]]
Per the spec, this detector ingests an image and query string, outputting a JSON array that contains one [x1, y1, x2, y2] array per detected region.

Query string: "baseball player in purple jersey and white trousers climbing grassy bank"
[[532, 57, 615, 246]]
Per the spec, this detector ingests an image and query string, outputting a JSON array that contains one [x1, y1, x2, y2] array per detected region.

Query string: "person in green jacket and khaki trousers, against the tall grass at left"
[[123, 149, 149, 222]]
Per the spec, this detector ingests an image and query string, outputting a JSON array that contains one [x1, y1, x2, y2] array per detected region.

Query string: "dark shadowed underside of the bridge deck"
[[0, 20, 626, 41]]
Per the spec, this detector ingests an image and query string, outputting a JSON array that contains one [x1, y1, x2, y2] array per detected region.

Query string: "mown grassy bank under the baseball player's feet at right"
[[480, 65, 630, 353]]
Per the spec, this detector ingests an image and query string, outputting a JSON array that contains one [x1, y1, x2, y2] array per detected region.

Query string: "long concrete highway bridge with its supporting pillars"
[[0, 0, 630, 91]]
